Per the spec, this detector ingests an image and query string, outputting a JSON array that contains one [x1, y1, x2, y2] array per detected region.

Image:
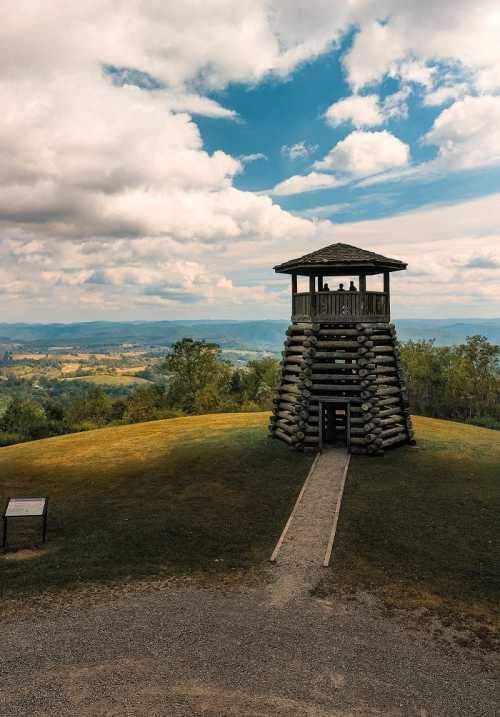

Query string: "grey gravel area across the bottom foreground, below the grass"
[[0, 588, 500, 717]]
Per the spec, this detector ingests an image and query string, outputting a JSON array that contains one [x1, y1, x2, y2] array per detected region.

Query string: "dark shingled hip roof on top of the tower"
[[274, 244, 407, 274]]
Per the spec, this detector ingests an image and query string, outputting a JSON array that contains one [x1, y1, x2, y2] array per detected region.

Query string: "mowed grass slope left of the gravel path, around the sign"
[[0, 413, 312, 596]]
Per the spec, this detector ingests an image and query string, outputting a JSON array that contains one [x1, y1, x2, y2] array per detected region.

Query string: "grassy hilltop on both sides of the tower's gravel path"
[[0, 413, 500, 644]]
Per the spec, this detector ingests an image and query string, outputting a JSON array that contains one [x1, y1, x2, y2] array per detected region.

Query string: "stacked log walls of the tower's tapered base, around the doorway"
[[270, 322, 414, 455]]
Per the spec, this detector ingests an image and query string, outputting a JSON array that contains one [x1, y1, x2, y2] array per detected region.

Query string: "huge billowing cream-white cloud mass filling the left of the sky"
[[0, 0, 328, 311]]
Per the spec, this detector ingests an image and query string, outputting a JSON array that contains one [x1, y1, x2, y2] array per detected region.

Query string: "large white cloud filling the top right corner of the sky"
[[345, 0, 500, 91]]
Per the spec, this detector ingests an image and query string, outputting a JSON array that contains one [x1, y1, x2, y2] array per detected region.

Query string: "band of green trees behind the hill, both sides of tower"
[[0, 336, 500, 445]]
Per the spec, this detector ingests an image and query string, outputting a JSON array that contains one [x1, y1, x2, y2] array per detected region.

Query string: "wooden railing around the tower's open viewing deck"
[[292, 291, 390, 323]]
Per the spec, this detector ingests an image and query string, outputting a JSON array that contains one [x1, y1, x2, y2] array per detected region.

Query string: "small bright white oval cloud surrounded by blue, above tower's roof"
[[314, 130, 410, 177]]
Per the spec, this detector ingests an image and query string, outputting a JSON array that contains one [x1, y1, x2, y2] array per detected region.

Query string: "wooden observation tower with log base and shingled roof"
[[270, 244, 414, 455]]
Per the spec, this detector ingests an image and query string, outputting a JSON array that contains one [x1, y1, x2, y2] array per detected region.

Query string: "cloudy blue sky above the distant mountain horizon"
[[0, 0, 500, 322]]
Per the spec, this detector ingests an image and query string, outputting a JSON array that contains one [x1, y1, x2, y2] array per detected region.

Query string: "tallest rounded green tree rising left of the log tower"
[[165, 339, 231, 413]]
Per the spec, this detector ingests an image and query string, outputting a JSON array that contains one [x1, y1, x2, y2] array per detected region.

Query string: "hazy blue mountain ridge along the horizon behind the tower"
[[0, 318, 500, 352]]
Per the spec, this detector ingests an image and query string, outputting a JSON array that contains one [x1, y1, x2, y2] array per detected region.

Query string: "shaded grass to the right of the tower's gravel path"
[[316, 417, 500, 648]]
